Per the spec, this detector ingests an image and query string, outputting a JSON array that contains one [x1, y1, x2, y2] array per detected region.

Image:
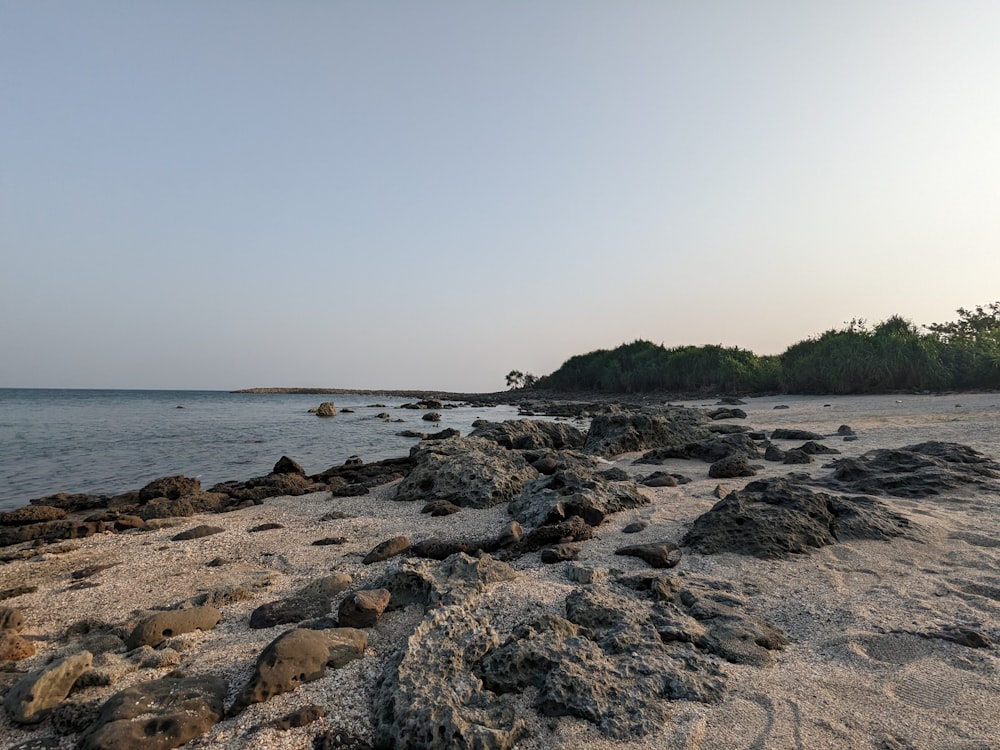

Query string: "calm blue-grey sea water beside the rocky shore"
[[0, 388, 532, 510]]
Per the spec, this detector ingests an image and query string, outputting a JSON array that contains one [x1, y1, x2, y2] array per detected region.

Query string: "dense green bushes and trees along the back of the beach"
[[528, 302, 1000, 393]]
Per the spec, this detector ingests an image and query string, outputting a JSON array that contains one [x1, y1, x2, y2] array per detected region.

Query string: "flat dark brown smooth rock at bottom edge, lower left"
[[81, 675, 228, 750]]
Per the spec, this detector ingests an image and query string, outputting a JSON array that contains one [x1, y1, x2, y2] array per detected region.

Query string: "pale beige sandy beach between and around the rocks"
[[0, 394, 1000, 750]]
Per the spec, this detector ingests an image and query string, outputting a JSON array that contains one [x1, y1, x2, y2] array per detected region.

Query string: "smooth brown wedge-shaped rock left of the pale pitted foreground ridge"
[[229, 628, 368, 715]]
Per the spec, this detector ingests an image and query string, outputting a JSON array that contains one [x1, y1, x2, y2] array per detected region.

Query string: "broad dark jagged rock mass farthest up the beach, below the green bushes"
[[583, 407, 709, 457]]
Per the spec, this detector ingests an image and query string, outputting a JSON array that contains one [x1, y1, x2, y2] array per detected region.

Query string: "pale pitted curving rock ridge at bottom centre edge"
[[374, 606, 525, 750]]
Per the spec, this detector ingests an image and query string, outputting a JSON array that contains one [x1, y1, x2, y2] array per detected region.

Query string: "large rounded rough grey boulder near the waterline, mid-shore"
[[395, 437, 538, 508]]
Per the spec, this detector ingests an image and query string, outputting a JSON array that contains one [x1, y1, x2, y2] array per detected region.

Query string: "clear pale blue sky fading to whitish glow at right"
[[0, 0, 1000, 391]]
